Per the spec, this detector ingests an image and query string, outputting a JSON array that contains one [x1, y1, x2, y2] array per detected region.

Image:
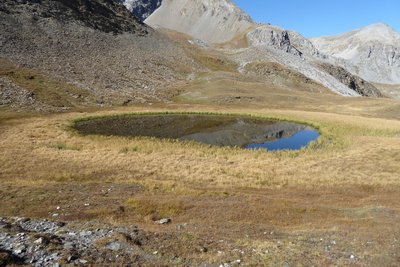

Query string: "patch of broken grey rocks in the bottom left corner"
[[0, 217, 172, 267]]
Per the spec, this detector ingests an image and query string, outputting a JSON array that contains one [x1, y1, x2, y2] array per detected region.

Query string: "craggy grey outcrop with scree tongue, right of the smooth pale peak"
[[232, 25, 377, 96]]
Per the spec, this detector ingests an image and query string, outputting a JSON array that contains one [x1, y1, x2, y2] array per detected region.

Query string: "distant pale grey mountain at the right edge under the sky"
[[312, 24, 400, 84]]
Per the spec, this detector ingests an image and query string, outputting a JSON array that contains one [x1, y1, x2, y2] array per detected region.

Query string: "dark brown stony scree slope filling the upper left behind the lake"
[[0, 0, 198, 109]]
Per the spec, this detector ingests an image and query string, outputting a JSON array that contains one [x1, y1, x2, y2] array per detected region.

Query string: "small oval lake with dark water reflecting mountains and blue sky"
[[73, 114, 320, 151]]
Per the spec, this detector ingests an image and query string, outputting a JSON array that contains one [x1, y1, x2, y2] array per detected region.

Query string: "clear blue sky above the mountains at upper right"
[[232, 0, 400, 37]]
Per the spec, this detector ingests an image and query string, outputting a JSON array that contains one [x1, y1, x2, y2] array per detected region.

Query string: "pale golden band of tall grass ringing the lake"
[[0, 108, 400, 191]]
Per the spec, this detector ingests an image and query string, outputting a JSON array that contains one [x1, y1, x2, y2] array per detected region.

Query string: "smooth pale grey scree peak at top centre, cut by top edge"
[[145, 0, 253, 43]]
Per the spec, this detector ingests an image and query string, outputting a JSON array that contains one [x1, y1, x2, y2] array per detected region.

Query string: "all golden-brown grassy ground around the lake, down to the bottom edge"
[[0, 90, 400, 266]]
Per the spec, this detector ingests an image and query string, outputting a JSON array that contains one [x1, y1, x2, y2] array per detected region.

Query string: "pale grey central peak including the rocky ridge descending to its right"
[[145, 0, 382, 96]]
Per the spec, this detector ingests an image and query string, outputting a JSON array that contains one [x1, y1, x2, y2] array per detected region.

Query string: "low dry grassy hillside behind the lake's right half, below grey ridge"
[[175, 75, 400, 119]]
